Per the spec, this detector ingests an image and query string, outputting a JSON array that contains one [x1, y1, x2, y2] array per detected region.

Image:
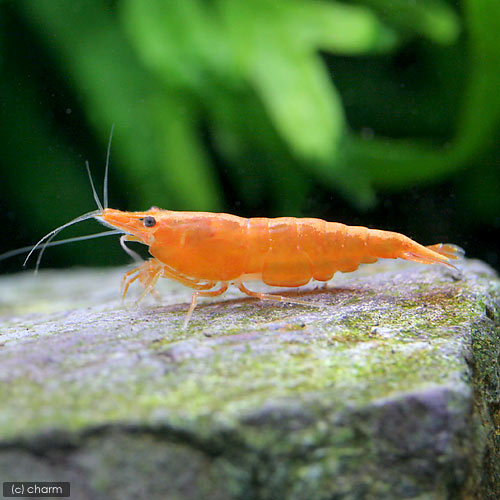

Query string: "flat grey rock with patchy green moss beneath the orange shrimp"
[[0, 260, 500, 500]]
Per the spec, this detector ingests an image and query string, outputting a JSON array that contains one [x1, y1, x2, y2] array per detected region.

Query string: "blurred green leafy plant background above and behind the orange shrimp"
[[0, 0, 500, 270]]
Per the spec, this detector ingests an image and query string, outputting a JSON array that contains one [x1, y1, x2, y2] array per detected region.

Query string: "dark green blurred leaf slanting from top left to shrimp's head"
[[19, 0, 219, 210]]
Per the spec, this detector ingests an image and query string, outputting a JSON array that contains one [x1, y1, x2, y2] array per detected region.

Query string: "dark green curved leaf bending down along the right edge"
[[348, 0, 500, 193]]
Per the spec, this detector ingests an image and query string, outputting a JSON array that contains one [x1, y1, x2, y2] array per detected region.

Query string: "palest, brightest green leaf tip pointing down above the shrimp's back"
[[220, 0, 345, 161]]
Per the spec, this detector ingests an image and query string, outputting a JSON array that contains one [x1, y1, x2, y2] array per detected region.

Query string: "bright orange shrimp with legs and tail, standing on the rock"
[[99, 207, 458, 325]]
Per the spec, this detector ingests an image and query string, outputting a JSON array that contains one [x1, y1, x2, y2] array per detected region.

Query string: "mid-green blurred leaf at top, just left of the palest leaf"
[[121, 0, 236, 95]]
